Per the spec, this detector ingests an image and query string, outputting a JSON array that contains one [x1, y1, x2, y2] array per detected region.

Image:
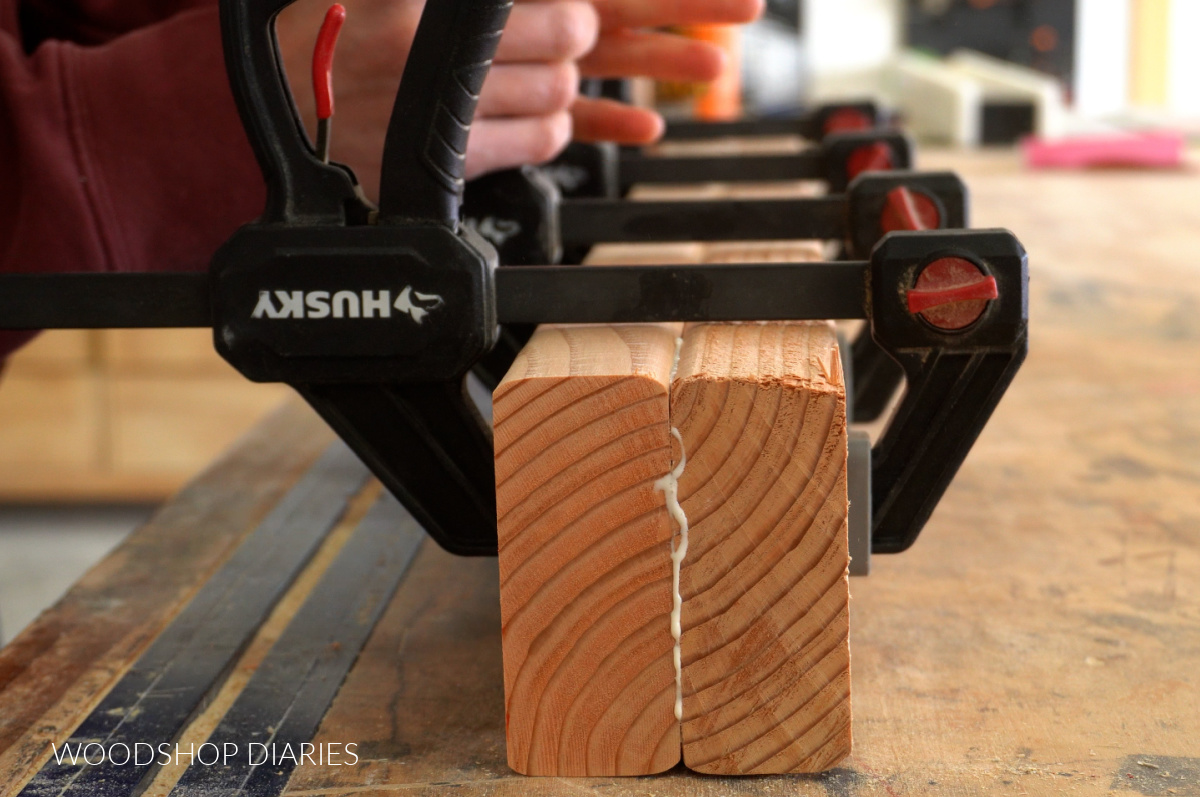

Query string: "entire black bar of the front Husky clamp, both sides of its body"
[[0, 262, 868, 329]]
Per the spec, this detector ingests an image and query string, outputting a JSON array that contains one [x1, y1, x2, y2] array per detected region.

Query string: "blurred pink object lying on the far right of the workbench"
[[1021, 131, 1186, 169]]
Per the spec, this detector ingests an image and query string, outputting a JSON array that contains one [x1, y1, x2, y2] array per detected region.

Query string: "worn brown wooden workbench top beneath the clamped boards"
[[0, 147, 1200, 797]]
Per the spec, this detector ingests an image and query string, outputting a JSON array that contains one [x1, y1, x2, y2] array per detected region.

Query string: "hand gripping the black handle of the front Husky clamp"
[[276, 0, 600, 198]]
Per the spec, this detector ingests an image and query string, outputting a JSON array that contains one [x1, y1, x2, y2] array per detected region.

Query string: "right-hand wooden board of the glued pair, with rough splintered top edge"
[[671, 322, 851, 774]]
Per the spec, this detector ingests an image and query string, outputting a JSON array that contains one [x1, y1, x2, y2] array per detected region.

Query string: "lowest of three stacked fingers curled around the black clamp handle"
[[467, 110, 571, 180]]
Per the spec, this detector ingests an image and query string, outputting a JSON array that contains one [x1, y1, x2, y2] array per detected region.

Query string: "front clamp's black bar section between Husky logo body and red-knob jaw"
[[496, 262, 870, 324]]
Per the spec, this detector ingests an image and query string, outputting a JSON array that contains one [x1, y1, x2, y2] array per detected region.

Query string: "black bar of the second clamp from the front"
[[558, 194, 848, 245]]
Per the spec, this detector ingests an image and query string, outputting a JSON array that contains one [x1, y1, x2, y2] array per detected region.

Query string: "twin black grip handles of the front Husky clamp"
[[221, 0, 512, 227]]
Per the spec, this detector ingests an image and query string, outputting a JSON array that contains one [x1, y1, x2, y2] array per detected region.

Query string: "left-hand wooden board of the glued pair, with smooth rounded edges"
[[493, 324, 679, 775]]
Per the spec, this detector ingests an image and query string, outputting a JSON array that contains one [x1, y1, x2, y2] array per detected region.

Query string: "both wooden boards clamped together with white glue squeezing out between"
[[494, 322, 851, 775]]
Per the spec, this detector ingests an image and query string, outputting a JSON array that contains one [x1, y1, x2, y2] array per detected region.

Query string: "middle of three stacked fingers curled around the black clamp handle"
[[476, 61, 580, 116]]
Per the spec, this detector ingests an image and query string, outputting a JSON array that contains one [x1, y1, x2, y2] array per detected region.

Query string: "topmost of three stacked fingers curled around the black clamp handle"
[[496, 0, 600, 62]]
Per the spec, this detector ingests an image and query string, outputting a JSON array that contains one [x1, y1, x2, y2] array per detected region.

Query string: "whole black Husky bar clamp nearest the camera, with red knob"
[[0, 0, 1027, 555]]
